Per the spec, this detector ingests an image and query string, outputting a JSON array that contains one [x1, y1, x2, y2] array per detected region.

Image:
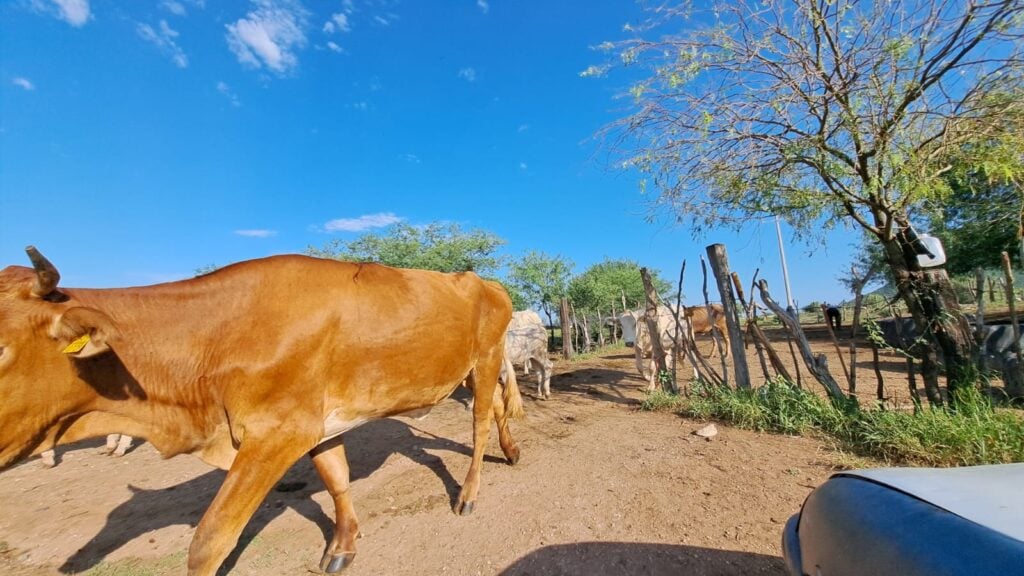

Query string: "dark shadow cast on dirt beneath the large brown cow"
[[59, 418, 497, 574]]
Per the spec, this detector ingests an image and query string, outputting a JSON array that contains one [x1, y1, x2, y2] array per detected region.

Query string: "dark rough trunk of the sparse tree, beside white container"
[[882, 228, 976, 405]]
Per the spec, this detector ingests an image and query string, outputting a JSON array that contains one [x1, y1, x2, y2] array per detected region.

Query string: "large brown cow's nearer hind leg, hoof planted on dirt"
[[455, 351, 502, 516]]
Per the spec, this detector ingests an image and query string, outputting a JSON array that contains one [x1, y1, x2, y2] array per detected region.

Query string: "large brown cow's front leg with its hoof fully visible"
[[309, 437, 359, 574]]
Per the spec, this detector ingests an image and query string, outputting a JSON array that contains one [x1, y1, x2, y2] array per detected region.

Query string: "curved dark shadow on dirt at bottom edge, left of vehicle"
[[499, 542, 786, 576]]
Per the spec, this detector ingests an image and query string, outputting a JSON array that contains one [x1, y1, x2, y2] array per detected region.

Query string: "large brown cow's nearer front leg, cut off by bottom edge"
[[188, 418, 319, 576]]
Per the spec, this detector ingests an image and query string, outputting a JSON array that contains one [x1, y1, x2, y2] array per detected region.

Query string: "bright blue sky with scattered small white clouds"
[[0, 0, 854, 304]]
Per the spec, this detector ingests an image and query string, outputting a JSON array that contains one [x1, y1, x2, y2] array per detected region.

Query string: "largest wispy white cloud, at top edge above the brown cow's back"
[[226, 0, 308, 74]]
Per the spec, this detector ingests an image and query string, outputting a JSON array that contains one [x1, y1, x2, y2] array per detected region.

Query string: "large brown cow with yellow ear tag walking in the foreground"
[[0, 246, 522, 576]]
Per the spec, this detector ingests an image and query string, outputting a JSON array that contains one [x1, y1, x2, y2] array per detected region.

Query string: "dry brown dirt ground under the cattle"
[[0, 325, 905, 576]]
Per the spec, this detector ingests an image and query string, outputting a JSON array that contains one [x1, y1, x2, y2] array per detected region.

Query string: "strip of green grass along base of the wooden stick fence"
[[644, 380, 1024, 466]]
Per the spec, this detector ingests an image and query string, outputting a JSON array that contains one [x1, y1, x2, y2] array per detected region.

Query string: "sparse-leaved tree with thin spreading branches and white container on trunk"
[[598, 0, 1024, 402]]
